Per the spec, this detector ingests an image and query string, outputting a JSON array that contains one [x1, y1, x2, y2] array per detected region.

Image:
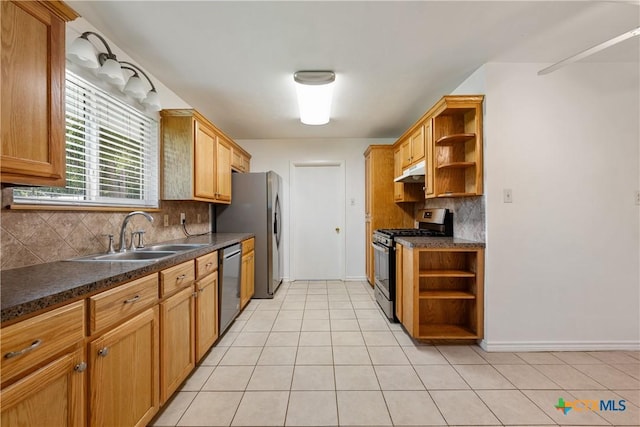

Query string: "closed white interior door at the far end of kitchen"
[[291, 162, 345, 280]]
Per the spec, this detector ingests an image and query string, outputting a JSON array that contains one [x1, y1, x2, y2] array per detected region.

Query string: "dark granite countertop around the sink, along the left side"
[[0, 233, 254, 323]]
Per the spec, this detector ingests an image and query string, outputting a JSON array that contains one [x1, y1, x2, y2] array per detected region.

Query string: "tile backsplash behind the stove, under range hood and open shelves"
[[416, 196, 486, 242]]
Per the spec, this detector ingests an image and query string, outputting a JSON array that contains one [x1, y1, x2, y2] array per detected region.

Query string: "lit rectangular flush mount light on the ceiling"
[[293, 71, 336, 125]]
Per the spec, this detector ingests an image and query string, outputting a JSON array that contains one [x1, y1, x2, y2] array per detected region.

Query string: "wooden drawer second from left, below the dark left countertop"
[[89, 274, 158, 334]]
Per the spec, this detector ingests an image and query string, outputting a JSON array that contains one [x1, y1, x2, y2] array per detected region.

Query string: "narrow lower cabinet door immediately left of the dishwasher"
[[195, 273, 218, 360]]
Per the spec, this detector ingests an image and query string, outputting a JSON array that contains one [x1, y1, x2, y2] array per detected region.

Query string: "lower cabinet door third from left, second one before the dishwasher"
[[160, 286, 196, 403]]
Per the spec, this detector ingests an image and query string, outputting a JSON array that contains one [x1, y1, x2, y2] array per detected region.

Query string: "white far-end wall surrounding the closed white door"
[[236, 139, 394, 280]]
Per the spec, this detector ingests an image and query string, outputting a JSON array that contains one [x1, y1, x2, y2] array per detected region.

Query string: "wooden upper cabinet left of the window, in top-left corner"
[[0, 1, 78, 186]]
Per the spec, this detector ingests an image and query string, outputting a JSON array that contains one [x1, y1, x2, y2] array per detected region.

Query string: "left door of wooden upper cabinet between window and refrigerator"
[[193, 122, 216, 200]]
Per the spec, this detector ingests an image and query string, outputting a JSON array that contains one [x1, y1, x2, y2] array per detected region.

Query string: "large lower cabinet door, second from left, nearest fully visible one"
[[89, 306, 159, 426]]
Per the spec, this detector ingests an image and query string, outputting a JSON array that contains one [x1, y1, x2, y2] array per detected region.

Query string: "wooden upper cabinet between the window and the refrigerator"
[[160, 110, 239, 203]]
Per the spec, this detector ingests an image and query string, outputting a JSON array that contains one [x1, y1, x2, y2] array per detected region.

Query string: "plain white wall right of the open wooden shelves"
[[461, 63, 640, 350]]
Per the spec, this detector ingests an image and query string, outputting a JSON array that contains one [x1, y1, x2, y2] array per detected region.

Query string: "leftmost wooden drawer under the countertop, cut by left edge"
[[0, 301, 84, 383]]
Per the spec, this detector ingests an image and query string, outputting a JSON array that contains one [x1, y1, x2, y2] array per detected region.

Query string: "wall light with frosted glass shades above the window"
[[67, 31, 162, 111]]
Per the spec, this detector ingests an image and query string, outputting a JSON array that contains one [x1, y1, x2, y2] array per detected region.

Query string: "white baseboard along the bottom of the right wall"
[[480, 340, 640, 352]]
